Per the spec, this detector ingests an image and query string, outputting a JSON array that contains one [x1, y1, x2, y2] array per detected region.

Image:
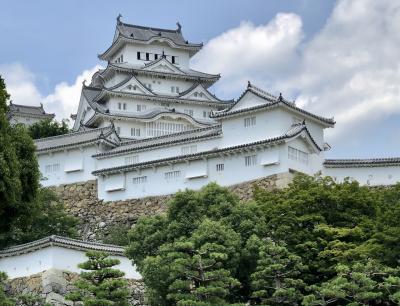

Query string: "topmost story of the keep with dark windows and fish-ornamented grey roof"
[[99, 15, 203, 69]]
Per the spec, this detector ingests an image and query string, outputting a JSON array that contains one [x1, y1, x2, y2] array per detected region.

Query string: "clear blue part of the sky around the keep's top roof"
[[0, 0, 333, 94]]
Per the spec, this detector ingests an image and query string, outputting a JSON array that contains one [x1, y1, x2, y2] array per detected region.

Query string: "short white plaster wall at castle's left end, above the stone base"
[[37, 144, 98, 187]]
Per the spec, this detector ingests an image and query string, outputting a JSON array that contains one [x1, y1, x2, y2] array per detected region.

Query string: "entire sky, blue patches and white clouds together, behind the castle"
[[0, 0, 400, 158]]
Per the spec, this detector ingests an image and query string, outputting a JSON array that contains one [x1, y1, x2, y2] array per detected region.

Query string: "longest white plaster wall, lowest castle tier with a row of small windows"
[[98, 145, 315, 201]]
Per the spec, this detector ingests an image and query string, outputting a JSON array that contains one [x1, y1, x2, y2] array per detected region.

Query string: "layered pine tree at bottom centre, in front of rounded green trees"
[[166, 219, 240, 306]]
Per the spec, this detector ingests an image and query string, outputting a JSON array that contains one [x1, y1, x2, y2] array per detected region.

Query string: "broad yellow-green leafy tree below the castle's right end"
[[255, 175, 381, 285]]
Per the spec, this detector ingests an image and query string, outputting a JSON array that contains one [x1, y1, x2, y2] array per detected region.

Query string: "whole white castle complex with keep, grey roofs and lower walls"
[[36, 16, 400, 200]]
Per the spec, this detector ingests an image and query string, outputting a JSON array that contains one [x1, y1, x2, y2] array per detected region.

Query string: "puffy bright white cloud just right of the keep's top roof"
[[193, 14, 303, 94]]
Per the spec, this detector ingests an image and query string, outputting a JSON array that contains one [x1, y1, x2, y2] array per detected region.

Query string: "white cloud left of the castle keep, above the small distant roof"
[[0, 63, 101, 120]]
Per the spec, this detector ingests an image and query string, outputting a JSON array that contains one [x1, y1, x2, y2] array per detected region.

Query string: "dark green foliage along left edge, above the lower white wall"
[[0, 77, 77, 248]]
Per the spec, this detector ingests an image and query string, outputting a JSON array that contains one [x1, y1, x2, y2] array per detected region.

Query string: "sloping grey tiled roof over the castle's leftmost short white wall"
[[35, 125, 117, 152]]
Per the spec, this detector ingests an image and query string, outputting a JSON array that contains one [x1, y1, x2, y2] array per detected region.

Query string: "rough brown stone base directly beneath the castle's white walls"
[[54, 173, 293, 241]]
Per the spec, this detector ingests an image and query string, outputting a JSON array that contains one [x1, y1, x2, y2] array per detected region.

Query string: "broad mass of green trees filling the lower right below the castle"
[[127, 175, 400, 306]]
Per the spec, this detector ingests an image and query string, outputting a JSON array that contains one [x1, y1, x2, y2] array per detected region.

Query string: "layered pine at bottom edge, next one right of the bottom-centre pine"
[[251, 238, 304, 305]]
